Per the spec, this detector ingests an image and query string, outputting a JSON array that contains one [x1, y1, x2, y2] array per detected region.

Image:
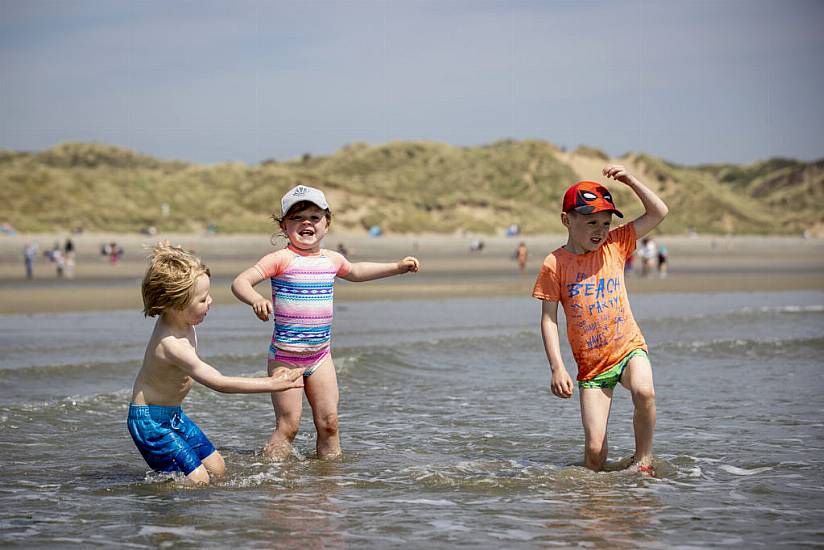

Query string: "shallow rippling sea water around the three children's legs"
[[0, 292, 824, 548]]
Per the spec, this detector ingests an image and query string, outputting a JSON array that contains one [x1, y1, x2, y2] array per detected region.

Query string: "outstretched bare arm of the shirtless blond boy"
[[164, 340, 305, 393]]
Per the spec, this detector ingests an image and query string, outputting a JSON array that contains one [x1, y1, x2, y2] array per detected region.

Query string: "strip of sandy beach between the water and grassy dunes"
[[0, 232, 824, 314]]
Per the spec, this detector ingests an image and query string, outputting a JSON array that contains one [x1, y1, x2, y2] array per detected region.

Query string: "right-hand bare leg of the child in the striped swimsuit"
[[304, 355, 342, 459]]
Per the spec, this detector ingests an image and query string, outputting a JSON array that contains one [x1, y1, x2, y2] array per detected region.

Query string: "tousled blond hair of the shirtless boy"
[[142, 241, 211, 317]]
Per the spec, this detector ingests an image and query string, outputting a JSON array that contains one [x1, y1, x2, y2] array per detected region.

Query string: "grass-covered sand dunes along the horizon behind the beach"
[[0, 140, 824, 233]]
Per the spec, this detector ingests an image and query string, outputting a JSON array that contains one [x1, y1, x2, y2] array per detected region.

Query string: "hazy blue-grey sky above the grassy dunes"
[[0, 0, 824, 164]]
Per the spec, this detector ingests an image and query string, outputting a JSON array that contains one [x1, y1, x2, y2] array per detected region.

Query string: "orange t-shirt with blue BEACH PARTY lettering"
[[532, 223, 647, 380]]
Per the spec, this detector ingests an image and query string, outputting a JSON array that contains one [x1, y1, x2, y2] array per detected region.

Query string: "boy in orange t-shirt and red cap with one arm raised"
[[532, 165, 668, 475]]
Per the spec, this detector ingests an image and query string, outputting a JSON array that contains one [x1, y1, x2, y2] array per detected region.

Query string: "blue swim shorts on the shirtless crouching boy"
[[127, 403, 215, 475]]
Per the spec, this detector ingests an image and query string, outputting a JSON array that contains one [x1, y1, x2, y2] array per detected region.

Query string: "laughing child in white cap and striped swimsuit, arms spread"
[[232, 185, 420, 459]]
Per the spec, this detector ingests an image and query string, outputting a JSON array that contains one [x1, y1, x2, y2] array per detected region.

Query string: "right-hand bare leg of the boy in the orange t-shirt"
[[621, 356, 655, 466]]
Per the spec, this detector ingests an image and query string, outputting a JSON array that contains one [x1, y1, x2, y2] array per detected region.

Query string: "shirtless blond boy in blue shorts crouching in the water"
[[128, 243, 303, 484]]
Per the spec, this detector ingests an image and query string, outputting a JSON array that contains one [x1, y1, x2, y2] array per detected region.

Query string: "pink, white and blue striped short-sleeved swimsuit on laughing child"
[[255, 245, 351, 376]]
